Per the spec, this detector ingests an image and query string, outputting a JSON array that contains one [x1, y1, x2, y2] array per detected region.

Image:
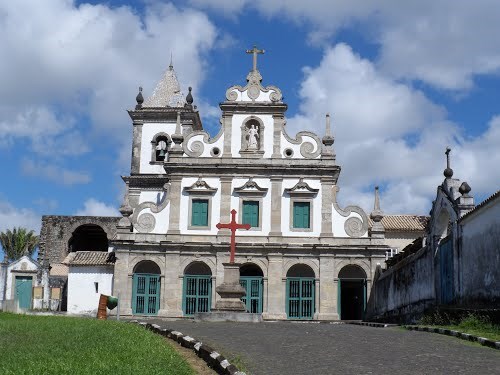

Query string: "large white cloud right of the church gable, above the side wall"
[[287, 44, 500, 213]]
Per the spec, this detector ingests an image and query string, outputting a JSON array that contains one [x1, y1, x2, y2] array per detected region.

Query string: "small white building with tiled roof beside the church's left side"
[[64, 251, 113, 315]]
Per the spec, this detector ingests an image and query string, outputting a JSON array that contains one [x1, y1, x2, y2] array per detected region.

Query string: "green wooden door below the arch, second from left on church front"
[[182, 275, 212, 316]]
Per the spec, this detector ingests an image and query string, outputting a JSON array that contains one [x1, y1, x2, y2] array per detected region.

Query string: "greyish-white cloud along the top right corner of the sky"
[[192, 0, 500, 90]]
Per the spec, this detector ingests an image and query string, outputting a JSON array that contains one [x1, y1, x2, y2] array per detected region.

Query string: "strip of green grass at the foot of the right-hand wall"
[[420, 314, 500, 341]]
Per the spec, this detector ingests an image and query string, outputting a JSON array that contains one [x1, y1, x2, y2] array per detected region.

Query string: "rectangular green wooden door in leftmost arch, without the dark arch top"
[[132, 273, 160, 315]]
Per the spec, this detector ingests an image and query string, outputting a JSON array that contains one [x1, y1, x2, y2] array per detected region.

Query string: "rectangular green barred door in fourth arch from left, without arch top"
[[286, 277, 314, 319]]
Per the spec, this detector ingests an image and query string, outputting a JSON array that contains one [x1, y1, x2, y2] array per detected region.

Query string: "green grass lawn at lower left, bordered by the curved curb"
[[0, 313, 195, 375]]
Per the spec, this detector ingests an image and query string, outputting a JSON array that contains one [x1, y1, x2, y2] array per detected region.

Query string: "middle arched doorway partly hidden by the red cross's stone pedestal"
[[240, 263, 264, 314]]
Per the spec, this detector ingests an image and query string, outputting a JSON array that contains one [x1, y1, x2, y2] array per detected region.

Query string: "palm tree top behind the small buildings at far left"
[[0, 228, 38, 261]]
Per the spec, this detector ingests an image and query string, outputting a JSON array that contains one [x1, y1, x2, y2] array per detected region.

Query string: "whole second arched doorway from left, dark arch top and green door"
[[182, 262, 212, 316]]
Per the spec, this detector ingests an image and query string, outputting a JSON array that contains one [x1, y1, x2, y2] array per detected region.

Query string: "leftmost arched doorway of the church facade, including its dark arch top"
[[132, 260, 161, 315]]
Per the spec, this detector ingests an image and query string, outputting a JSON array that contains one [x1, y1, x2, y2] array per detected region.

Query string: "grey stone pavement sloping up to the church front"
[[147, 319, 500, 375]]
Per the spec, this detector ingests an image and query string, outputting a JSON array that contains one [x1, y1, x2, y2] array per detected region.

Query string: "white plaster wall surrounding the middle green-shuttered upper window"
[[231, 178, 271, 236]]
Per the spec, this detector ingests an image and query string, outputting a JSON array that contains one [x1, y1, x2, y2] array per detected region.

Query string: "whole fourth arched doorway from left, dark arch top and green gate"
[[286, 264, 315, 319]]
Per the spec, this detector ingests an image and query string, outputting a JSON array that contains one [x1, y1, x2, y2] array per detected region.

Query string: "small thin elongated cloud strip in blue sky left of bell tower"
[[21, 159, 91, 185]]
